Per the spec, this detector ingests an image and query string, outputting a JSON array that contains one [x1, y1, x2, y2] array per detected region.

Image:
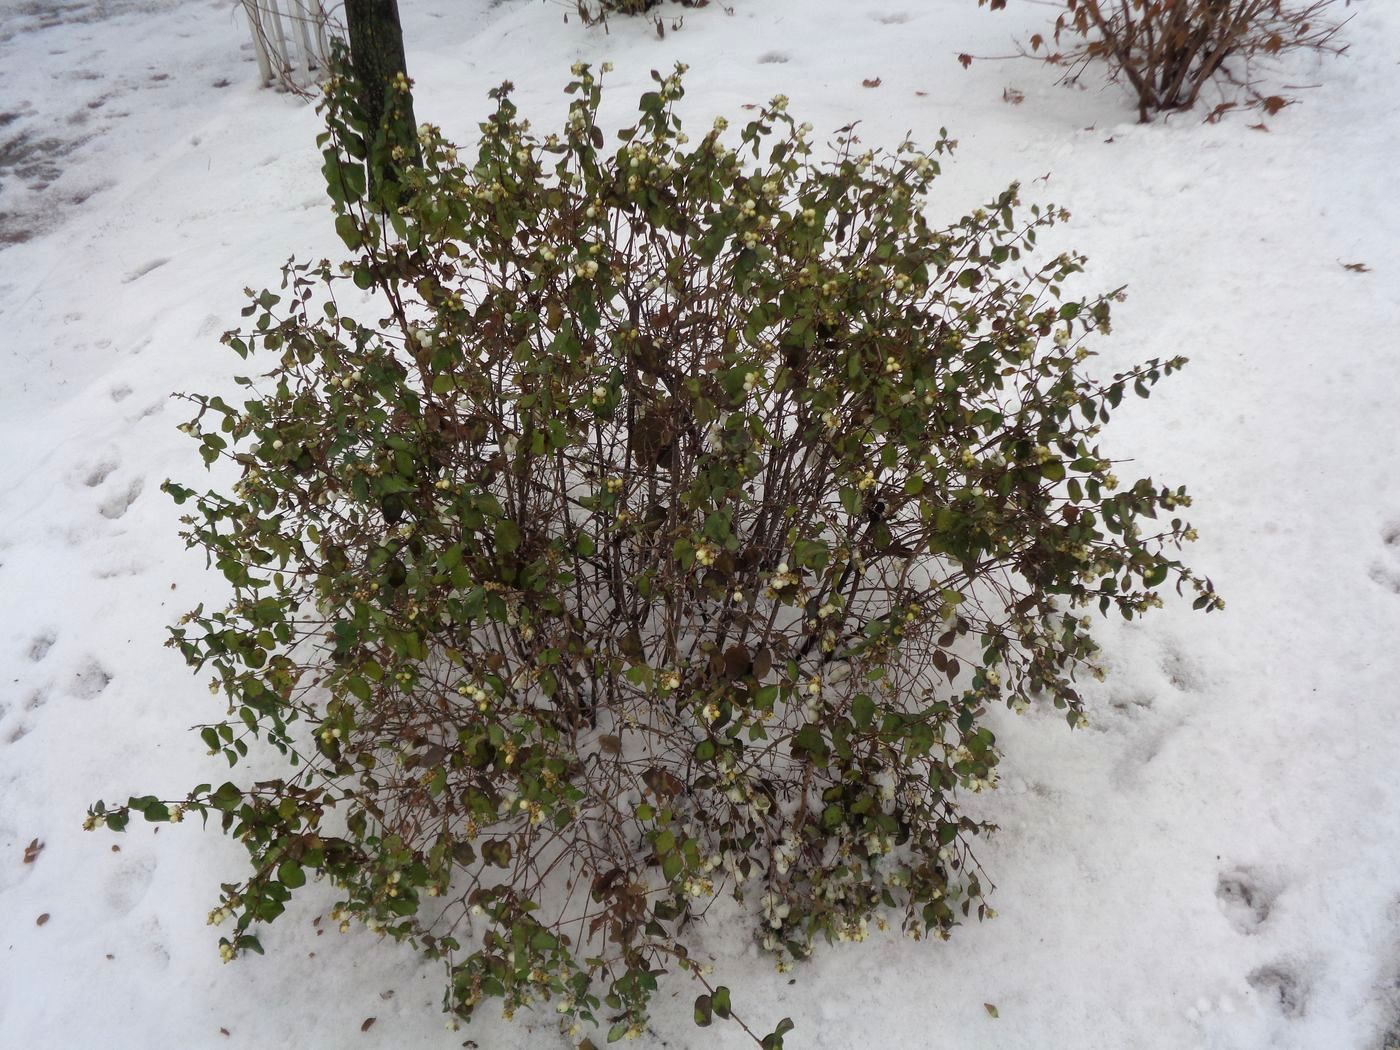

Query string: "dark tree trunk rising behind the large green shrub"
[[344, 0, 419, 179]]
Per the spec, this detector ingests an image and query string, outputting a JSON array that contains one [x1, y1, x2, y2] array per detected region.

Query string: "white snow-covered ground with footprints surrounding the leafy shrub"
[[0, 0, 1400, 1050]]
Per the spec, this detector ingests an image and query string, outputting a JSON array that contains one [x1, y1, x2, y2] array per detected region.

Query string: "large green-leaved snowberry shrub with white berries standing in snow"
[[90, 66, 1219, 1047]]
